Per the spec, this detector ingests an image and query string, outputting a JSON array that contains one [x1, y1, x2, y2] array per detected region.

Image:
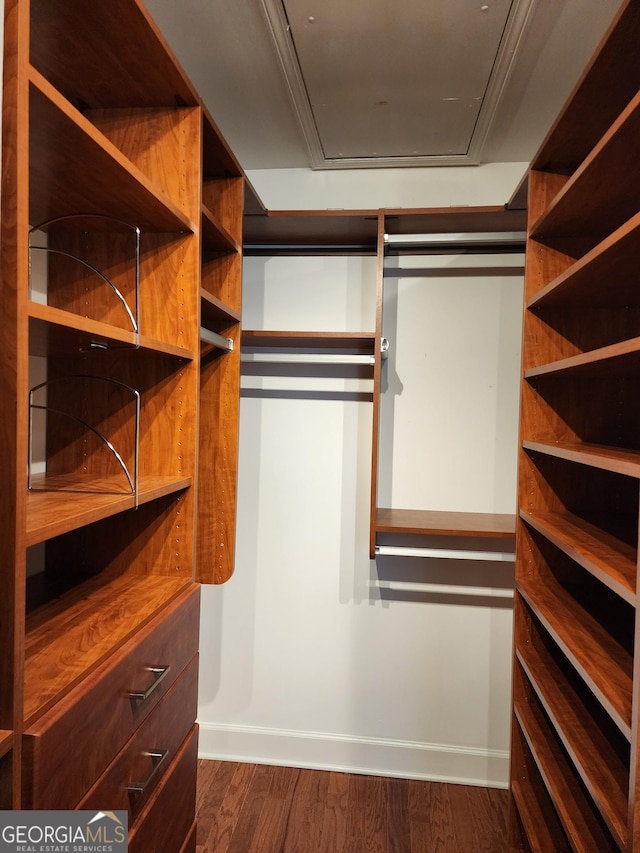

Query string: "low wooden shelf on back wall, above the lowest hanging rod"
[[376, 507, 516, 539]]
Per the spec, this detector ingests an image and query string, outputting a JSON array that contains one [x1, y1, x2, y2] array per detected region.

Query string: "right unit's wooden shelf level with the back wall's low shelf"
[[520, 510, 637, 607]]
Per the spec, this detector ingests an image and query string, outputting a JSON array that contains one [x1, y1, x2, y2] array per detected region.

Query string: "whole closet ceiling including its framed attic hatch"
[[146, 0, 620, 171]]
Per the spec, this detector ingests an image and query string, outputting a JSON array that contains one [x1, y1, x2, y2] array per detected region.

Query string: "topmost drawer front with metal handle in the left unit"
[[22, 585, 200, 809]]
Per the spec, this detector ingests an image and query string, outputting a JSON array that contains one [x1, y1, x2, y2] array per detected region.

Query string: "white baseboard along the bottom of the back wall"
[[199, 722, 509, 788]]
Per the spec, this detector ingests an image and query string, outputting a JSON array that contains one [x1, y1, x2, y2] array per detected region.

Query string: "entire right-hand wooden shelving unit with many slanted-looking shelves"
[[511, 0, 640, 851]]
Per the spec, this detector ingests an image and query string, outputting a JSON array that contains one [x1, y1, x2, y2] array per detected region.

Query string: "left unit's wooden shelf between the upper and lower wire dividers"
[[29, 302, 193, 361]]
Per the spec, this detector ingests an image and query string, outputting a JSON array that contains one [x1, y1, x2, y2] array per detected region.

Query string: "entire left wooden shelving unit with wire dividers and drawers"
[[0, 0, 244, 840]]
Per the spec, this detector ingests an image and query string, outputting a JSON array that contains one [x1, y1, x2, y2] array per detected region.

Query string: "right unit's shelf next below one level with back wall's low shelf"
[[516, 577, 633, 740]]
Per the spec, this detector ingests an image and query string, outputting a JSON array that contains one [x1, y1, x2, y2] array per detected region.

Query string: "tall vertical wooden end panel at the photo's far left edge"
[[0, 0, 29, 744]]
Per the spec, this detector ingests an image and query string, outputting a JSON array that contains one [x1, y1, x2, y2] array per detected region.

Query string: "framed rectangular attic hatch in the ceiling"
[[262, 0, 535, 169]]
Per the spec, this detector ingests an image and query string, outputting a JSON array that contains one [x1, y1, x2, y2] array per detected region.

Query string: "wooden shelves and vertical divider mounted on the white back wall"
[[242, 206, 526, 559]]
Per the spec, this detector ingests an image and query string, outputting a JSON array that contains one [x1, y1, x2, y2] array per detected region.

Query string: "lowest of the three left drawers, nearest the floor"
[[129, 726, 198, 853]]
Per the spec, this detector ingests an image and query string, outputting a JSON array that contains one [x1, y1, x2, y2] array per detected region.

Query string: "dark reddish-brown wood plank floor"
[[196, 761, 508, 853]]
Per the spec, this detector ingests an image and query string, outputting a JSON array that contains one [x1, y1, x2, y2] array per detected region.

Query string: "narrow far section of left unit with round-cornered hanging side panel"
[[196, 110, 245, 583]]
